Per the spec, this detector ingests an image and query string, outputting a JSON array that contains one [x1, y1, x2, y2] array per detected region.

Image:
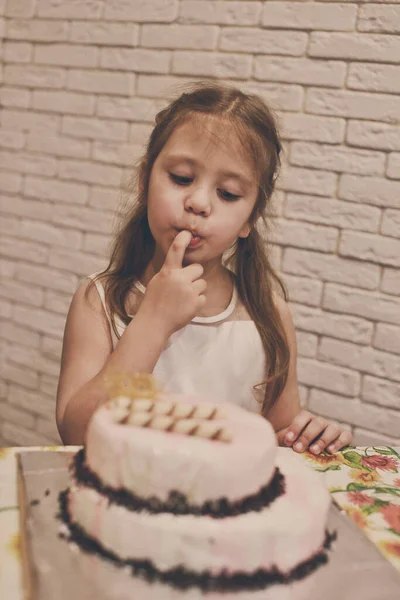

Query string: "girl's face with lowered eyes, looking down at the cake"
[[147, 119, 258, 266]]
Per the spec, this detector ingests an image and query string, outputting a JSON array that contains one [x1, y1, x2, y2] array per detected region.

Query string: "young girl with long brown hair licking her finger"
[[57, 83, 351, 453]]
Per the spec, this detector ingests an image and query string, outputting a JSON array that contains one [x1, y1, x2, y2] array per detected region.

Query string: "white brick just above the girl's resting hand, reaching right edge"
[[308, 390, 400, 436]]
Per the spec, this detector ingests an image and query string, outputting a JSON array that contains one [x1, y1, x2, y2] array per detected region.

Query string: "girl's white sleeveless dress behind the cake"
[[90, 275, 266, 413]]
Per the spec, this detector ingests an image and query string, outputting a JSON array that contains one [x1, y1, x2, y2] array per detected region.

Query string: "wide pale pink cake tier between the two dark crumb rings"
[[65, 451, 331, 576]]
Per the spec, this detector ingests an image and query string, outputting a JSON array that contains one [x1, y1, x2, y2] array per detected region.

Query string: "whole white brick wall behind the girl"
[[0, 0, 400, 444]]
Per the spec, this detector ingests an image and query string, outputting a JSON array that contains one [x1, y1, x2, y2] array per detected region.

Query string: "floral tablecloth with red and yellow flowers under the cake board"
[[0, 446, 400, 600]]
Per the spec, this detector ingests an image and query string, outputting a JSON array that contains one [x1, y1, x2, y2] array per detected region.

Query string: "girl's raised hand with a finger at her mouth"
[[139, 231, 207, 337]]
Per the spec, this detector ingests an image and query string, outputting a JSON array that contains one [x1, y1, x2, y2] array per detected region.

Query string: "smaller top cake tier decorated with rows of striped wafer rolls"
[[86, 376, 276, 503]]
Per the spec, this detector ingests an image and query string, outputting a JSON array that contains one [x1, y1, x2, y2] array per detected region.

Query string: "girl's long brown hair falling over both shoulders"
[[91, 82, 289, 415]]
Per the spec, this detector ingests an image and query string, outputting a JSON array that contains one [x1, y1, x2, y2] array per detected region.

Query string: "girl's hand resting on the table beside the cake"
[[278, 410, 351, 454]]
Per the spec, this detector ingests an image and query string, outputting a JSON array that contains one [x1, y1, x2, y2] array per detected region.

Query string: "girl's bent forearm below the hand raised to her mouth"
[[58, 313, 168, 445]]
